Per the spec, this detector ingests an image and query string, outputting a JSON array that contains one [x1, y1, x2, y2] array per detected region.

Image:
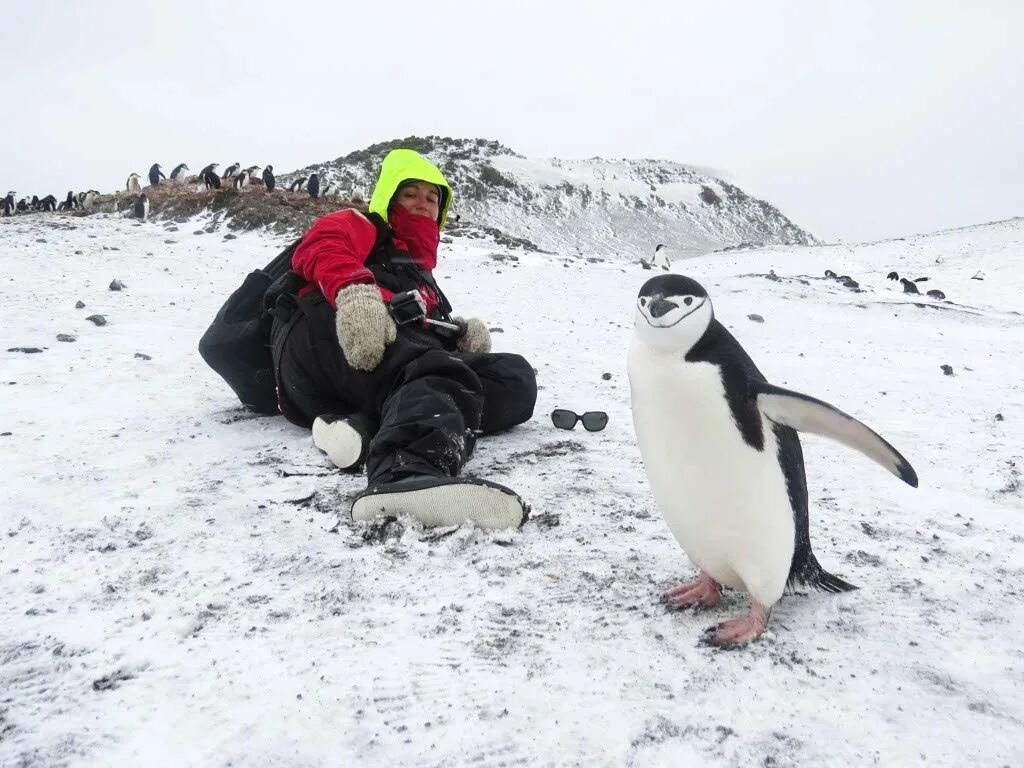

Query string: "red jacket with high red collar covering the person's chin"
[[292, 206, 440, 313]]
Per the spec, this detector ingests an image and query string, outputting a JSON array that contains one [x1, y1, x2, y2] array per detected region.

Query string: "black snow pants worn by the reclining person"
[[271, 294, 537, 484]]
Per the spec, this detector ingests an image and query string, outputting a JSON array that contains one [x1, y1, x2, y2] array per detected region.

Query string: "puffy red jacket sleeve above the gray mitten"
[[292, 210, 377, 306]]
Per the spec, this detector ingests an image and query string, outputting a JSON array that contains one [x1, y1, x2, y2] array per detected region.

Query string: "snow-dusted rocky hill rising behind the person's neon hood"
[[282, 136, 815, 259]]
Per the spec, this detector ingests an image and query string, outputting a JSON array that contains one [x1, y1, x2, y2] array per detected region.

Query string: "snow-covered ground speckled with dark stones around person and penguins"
[[0, 211, 1024, 767]]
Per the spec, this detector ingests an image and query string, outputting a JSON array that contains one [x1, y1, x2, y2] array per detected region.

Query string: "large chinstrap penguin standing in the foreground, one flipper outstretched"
[[628, 274, 918, 647]]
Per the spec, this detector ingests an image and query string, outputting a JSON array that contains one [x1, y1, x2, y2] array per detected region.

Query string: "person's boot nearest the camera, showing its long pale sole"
[[352, 477, 528, 530]]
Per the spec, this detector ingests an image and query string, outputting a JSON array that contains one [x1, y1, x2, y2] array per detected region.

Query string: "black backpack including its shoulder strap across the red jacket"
[[199, 213, 452, 416]]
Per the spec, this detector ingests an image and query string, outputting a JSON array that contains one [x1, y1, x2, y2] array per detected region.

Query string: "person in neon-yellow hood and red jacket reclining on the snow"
[[271, 150, 537, 528]]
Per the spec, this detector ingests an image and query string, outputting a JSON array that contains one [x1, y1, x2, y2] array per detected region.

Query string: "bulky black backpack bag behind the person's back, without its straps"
[[199, 238, 304, 415]]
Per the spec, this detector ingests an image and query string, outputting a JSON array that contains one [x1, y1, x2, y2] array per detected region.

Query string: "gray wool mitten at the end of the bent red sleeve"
[[335, 284, 397, 371]]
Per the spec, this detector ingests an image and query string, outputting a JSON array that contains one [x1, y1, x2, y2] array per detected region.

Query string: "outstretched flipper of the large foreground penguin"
[[755, 382, 918, 487]]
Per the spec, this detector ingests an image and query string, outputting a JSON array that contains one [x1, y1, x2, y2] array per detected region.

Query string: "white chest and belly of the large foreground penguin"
[[629, 341, 795, 606]]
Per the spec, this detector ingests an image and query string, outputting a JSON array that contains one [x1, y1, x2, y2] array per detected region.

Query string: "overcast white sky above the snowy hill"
[[0, 0, 1024, 241]]
